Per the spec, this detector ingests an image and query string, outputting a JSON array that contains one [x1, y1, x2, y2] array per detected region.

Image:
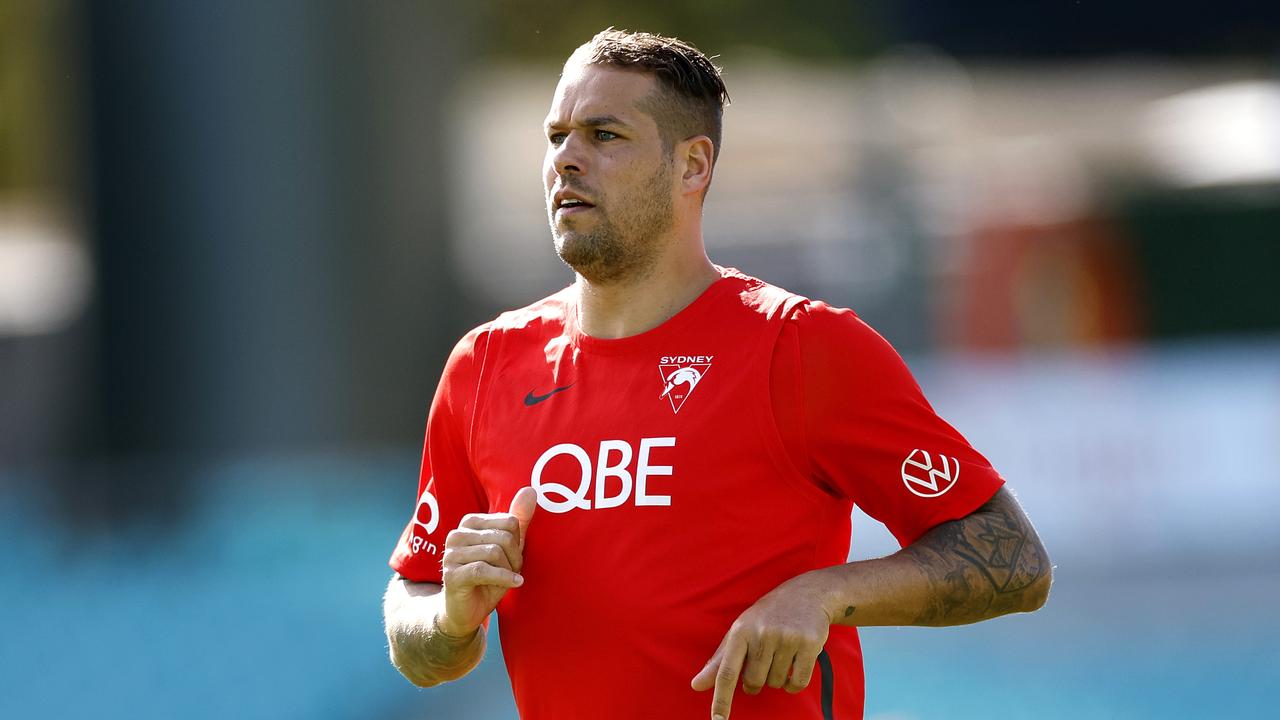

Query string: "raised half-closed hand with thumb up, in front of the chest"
[[436, 487, 538, 638]]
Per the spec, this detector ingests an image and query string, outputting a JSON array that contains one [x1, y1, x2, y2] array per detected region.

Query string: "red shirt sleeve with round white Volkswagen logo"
[[772, 302, 1004, 546]]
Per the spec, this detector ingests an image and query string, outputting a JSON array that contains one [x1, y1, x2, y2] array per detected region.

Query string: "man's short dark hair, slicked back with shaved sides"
[[571, 27, 728, 163]]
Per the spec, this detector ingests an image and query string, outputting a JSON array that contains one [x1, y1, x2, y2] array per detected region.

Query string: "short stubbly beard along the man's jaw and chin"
[[550, 164, 675, 284]]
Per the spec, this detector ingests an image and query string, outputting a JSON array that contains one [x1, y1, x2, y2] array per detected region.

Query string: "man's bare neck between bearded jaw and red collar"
[[576, 237, 721, 340]]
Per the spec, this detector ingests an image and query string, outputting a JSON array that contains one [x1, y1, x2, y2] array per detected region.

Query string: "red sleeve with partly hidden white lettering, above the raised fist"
[[390, 329, 489, 583]]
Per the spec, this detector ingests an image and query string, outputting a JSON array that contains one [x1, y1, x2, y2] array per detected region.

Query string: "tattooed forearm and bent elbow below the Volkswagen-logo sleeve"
[[814, 489, 1052, 626]]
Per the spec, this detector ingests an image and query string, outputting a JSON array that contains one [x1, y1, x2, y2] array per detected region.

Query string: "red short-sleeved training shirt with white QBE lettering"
[[390, 269, 1002, 720]]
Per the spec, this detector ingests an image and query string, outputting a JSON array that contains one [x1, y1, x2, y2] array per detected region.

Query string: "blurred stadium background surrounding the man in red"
[[0, 0, 1280, 720]]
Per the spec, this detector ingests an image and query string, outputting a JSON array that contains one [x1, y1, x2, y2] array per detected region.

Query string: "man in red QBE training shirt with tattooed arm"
[[384, 31, 1051, 720]]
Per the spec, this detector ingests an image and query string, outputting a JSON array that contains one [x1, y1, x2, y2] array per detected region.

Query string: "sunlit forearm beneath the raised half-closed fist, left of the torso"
[[383, 577, 485, 688]]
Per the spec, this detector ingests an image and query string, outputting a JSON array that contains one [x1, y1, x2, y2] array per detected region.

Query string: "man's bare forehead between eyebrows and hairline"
[[547, 60, 655, 127]]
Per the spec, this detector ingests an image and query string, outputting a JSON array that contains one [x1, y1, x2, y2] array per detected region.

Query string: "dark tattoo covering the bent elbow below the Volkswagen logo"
[[904, 489, 1051, 625]]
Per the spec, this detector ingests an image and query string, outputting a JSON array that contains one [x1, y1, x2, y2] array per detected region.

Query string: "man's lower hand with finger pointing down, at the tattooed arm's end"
[[691, 570, 832, 720]]
